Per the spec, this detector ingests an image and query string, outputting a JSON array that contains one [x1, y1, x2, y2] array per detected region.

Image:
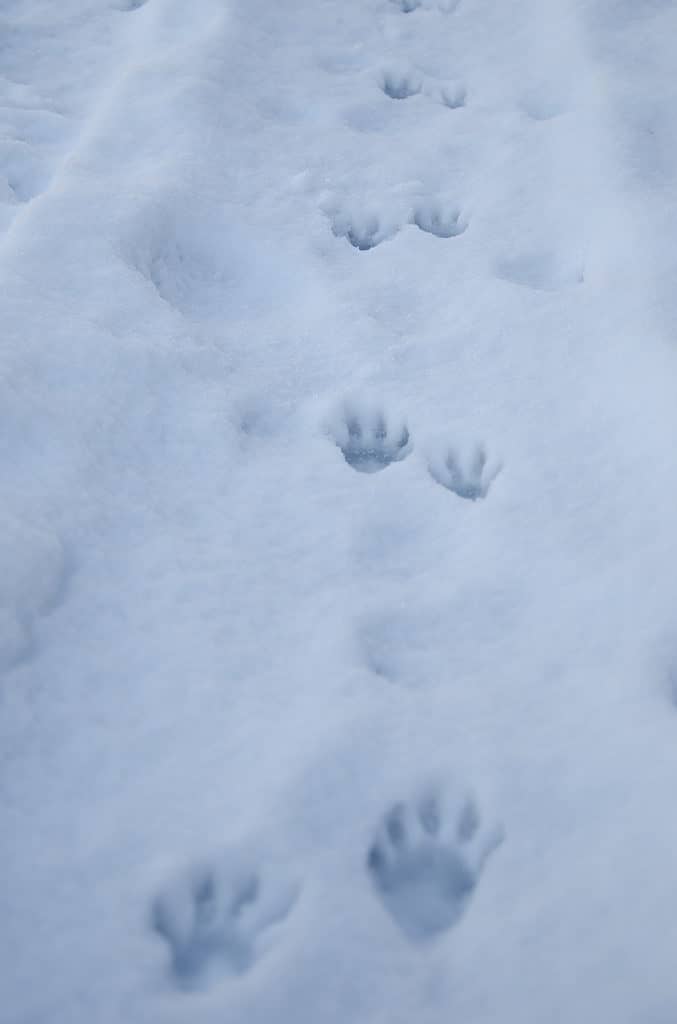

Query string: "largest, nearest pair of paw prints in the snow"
[[151, 792, 503, 990]]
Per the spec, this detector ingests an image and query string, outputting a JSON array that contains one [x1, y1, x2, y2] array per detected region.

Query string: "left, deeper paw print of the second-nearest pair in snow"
[[331, 404, 412, 473]]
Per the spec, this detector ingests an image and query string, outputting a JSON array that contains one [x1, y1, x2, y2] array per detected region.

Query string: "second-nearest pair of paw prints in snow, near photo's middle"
[[329, 402, 501, 502]]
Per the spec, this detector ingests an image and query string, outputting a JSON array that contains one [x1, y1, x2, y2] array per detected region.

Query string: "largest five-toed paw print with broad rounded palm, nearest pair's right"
[[367, 793, 503, 942]]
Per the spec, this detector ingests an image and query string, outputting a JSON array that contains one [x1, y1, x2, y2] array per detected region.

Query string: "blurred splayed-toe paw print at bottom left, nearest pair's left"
[[151, 858, 298, 989]]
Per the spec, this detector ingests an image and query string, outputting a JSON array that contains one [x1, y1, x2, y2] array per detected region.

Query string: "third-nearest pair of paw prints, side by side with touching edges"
[[326, 199, 468, 252]]
